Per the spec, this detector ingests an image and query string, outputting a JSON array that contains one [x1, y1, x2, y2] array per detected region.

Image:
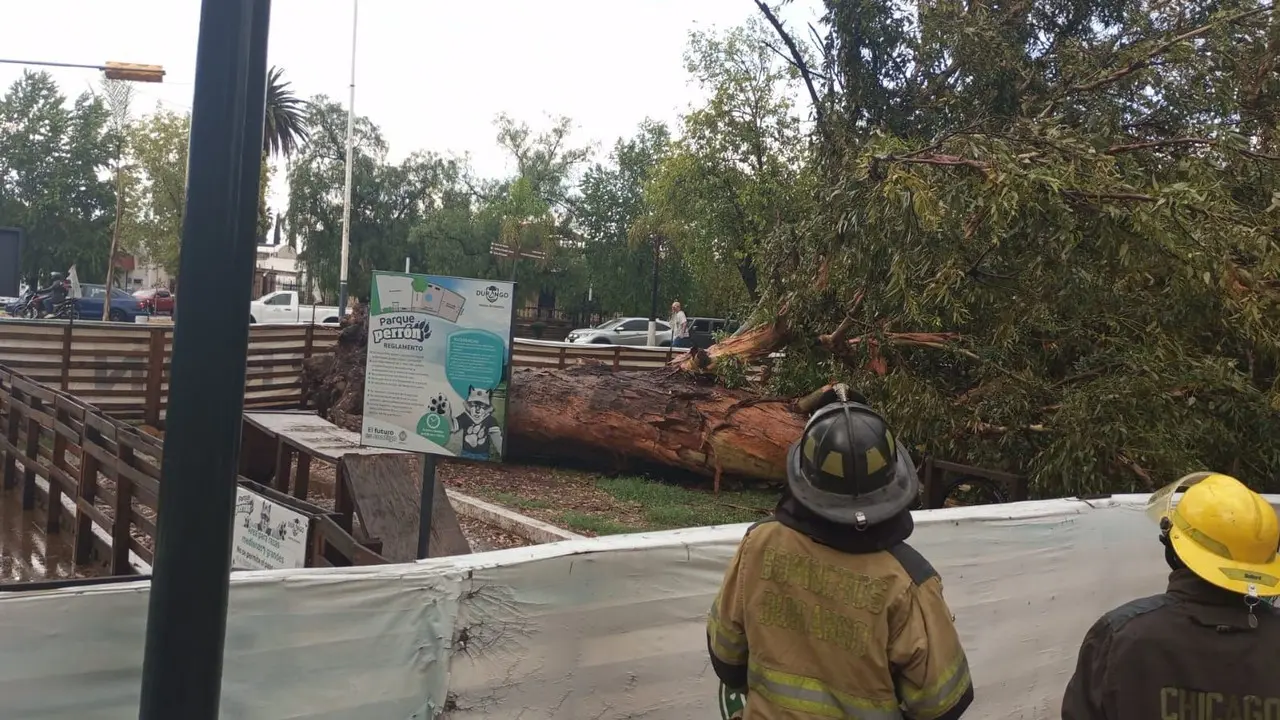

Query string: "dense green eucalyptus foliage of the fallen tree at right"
[[756, 0, 1280, 495]]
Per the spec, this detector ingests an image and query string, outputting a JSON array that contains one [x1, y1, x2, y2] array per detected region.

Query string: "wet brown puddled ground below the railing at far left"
[[0, 488, 86, 583]]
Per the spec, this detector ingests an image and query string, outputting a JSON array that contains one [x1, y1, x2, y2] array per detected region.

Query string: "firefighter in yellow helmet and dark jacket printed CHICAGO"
[[1062, 473, 1280, 720]]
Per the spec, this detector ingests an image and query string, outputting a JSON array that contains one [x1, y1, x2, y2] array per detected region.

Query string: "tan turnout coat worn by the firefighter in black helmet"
[[707, 520, 973, 720]]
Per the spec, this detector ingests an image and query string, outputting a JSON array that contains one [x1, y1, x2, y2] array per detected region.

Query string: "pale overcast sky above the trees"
[[0, 0, 818, 189]]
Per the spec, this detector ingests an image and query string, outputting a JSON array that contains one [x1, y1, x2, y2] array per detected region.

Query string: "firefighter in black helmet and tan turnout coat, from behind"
[[707, 386, 973, 720]]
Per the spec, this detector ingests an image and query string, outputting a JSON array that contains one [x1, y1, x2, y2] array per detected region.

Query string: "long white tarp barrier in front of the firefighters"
[[0, 497, 1275, 720]]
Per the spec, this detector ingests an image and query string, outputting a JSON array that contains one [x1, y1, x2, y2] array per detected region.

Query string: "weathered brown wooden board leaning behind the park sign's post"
[[342, 452, 471, 562]]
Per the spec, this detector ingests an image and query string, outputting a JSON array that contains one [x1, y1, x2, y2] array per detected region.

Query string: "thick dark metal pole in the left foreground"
[[138, 0, 270, 720]]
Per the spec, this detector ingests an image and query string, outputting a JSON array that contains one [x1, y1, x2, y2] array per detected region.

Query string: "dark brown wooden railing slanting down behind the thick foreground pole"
[[0, 368, 380, 575]]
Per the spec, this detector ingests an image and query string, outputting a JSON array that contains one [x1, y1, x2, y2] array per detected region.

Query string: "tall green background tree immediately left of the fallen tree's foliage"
[[649, 22, 806, 311]]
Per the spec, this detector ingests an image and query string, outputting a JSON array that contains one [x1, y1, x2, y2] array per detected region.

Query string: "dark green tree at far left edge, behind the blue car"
[[0, 72, 115, 286]]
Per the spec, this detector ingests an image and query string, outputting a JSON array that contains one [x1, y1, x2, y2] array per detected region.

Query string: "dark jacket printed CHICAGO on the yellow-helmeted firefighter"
[[1062, 569, 1280, 720]]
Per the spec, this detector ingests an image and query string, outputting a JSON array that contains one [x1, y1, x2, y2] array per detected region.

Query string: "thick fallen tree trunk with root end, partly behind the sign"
[[295, 304, 804, 487]]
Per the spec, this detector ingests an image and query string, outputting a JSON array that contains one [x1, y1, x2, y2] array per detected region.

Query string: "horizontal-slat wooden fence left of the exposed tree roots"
[[0, 319, 338, 425]]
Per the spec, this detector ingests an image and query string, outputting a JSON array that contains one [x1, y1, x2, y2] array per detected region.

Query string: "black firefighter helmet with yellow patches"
[[787, 392, 920, 529]]
